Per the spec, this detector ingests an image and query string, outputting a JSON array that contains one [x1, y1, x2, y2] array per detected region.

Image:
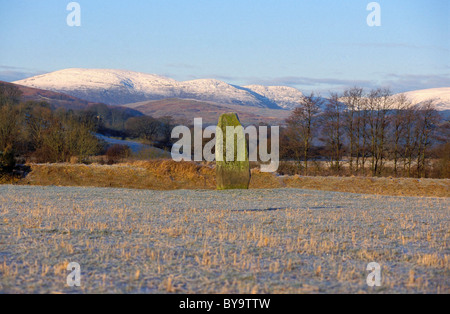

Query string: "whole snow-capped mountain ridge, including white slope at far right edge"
[[13, 68, 450, 111]]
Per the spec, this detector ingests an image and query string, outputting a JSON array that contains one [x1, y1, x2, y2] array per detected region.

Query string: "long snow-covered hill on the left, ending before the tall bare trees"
[[15, 69, 286, 109]]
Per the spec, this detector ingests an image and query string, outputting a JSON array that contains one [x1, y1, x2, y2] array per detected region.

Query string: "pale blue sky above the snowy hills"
[[0, 0, 450, 92]]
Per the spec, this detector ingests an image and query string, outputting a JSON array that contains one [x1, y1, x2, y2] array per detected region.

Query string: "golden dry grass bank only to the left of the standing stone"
[[19, 160, 215, 190]]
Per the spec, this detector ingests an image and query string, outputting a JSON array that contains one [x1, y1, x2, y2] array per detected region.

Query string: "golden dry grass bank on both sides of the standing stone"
[[11, 160, 450, 197]]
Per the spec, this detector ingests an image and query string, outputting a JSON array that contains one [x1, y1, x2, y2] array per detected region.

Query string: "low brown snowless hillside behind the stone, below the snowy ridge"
[[125, 98, 290, 125]]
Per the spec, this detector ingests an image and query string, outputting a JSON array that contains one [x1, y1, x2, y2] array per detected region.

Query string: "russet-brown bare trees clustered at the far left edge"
[[0, 84, 101, 168]]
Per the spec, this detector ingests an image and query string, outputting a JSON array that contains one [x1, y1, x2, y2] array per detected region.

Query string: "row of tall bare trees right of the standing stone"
[[282, 87, 448, 177]]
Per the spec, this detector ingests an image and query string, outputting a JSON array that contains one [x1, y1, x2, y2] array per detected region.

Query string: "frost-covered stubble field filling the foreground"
[[0, 186, 450, 293]]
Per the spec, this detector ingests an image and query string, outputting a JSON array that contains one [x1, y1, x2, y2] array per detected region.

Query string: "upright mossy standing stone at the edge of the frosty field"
[[216, 113, 250, 190]]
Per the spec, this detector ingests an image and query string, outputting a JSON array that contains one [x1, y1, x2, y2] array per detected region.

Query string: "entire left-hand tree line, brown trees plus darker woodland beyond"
[[0, 84, 172, 173]]
